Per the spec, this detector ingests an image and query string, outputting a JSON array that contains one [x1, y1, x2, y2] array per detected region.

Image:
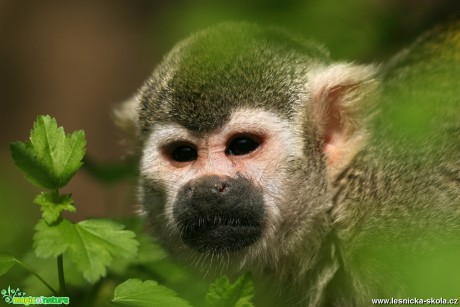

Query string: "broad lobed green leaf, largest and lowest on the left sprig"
[[34, 219, 139, 282]]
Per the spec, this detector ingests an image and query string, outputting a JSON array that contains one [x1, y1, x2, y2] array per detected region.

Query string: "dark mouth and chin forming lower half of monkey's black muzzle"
[[180, 218, 262, 253]]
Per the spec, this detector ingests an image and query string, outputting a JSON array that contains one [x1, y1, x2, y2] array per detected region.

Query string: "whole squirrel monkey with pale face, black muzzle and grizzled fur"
[[116, 20, 460, 306]]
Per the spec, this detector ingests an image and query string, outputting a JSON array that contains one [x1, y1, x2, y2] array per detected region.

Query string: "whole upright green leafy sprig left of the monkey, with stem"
[[4, 116, 138, 295]]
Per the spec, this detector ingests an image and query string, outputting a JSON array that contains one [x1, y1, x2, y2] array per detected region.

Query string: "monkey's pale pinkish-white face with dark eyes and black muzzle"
[[141, 109, 299, 253]]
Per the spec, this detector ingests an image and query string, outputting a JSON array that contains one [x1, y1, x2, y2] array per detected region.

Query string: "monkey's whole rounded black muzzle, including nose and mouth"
[[173, 175, 265, 254]]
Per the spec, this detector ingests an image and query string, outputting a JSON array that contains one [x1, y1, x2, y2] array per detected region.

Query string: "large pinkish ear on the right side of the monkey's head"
[[309, 64, 377, 175]]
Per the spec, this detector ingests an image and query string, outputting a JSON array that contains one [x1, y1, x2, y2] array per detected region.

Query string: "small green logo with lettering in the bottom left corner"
[[0, 286, 70, 306]]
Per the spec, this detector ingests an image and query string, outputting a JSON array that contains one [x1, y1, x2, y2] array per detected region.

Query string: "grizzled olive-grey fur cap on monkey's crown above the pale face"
[[140, 23, 328, 133]]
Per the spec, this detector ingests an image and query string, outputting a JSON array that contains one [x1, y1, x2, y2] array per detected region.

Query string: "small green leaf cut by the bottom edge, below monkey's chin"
[[205, 272, 254, 307]]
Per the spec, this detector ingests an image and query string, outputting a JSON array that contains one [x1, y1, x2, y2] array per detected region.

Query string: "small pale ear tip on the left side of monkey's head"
[[112, 96, 139, 140]]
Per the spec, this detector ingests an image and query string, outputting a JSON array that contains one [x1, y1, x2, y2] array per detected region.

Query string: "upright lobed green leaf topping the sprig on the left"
[[10, 115, 86, 190]]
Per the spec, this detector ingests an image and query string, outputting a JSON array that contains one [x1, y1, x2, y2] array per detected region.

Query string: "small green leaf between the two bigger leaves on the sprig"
[[34, 191, 77, 224]]
